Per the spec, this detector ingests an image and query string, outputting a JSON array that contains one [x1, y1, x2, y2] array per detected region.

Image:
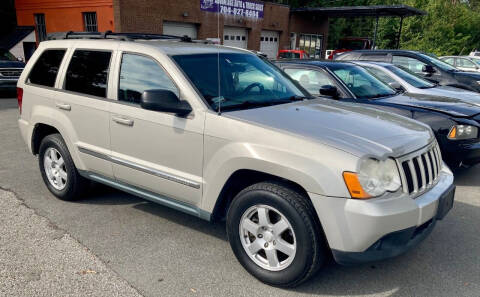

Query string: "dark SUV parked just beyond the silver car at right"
[[334, 50, 480, 92]]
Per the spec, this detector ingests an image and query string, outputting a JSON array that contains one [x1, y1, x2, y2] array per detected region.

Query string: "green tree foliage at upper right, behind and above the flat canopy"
[[291, 0, 480, 55]]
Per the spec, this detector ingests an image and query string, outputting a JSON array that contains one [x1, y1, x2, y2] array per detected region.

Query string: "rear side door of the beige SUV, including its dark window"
[[54, 42, 118, 177]]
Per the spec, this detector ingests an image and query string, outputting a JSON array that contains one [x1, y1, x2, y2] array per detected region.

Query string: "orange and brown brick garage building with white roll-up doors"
[[16, 0, 328, 58]]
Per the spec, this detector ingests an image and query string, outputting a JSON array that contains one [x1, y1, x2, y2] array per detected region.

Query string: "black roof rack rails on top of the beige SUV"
[[47, 31, 194, 42]]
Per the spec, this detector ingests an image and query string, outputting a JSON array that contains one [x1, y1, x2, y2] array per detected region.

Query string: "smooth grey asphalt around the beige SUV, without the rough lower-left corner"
[[0, 99, 480, 297]]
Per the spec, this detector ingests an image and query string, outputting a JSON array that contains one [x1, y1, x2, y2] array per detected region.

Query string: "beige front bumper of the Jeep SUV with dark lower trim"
[[310, 166, 455, 265]]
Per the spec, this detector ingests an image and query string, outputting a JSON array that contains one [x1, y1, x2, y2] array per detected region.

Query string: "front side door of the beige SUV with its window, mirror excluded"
[[110, 52, 204, 205]]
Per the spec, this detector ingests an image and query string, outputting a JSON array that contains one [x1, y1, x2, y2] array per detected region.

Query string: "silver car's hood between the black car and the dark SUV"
[[379, 91, 480, 117]]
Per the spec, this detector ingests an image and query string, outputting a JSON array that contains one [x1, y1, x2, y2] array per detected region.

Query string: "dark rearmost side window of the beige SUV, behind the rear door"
[[28, 50, 65, 87]]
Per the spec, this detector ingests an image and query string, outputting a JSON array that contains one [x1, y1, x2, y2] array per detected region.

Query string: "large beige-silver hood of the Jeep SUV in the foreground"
[[224, 98, 434, 158]]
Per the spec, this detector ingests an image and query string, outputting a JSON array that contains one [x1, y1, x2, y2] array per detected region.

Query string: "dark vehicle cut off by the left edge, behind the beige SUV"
[[0, 49, 25, 93]]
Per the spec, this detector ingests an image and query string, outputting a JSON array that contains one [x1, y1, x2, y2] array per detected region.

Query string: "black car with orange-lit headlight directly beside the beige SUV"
[[275, 60, 480, 168]]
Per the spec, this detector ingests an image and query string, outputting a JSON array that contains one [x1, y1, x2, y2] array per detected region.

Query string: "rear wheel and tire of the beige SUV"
[[38, 134, 89, 201]]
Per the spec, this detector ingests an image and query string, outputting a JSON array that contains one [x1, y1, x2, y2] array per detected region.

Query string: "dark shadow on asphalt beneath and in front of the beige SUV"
[[79, 180, 480, 296]]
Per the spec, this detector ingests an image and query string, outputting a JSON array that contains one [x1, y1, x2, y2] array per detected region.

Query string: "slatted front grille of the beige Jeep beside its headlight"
[[398, 141, 443, 195]]
